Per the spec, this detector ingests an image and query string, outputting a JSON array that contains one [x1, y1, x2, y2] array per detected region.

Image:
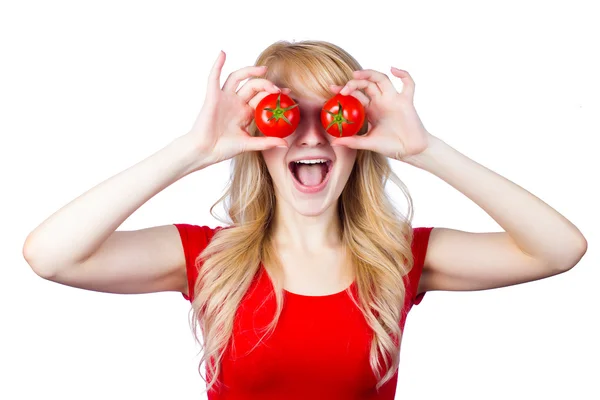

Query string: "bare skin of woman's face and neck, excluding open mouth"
[[262, 93, 357, 254]]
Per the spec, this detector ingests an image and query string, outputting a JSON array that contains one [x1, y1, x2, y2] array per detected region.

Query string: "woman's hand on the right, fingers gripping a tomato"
[[331, 67, 431, 161]]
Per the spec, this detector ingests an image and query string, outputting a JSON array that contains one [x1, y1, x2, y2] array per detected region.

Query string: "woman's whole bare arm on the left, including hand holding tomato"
[[23, 53, 289, 294]]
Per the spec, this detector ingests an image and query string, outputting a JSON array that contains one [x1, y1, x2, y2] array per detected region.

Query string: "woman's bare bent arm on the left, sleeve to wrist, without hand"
[[23, 135, 208, 293]]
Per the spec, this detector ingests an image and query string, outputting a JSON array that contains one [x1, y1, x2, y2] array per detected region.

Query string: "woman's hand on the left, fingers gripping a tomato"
[[186, 51, 290, 165]]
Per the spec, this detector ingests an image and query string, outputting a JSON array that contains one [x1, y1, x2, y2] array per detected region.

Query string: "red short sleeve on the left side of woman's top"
[[173, 224, 222, 302]]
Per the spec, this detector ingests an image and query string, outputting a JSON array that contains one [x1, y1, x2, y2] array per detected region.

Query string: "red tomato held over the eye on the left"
[[254, 93, 300, 138]]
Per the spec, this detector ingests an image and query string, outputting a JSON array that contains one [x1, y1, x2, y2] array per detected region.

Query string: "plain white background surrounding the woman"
[[0, 0, 600, 400]]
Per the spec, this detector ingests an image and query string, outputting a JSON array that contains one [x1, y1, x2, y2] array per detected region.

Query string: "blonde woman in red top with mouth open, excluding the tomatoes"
[[23, 41, 587, 399]]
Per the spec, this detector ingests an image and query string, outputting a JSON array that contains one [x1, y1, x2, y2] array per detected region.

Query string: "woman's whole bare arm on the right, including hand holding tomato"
[[331, 67, 587, 293]]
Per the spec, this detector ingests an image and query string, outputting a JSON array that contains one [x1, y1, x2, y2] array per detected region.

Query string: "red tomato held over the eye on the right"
[[321, 93, 365, 137]]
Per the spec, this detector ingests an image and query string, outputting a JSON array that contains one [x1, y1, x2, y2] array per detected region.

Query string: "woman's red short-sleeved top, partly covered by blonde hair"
[[175, 224, 432, 400]]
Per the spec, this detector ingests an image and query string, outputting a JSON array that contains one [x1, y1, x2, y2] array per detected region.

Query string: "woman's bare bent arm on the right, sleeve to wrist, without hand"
[[402, 134, 587, 292]]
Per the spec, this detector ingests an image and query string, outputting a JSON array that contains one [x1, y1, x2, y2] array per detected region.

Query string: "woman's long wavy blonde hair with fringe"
[[191, 41, 413, 391]]
